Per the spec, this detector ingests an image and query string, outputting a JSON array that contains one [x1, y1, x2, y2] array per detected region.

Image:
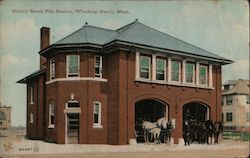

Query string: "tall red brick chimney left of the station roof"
[[40, 27, 50, 69]]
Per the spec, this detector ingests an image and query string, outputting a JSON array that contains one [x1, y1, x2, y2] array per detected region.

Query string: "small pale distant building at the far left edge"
[[0, 104, 11, 130]]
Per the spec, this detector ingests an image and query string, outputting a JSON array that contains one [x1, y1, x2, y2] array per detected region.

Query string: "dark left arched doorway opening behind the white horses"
[[135, 99, 168, 142]]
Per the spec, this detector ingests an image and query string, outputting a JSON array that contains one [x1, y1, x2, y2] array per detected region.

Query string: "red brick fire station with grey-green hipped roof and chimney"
[[18, 20, 232, 144]]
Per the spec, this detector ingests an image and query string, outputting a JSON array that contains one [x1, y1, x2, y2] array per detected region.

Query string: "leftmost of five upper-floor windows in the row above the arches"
[[140, 56, 150, 79]]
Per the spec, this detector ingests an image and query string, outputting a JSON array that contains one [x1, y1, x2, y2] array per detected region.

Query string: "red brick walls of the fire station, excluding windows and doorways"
[[19, 21, 230, 145]]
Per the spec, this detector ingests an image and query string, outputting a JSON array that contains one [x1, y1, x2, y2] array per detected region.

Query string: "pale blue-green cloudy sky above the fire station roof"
[[0, 0, 249, 126]]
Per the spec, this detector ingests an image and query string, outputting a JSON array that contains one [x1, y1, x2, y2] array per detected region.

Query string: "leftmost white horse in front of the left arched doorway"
[[142, 121, 161, 144]]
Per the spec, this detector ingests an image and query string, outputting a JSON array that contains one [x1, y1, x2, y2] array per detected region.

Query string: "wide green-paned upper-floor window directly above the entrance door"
[[67, 55, 79, 77]]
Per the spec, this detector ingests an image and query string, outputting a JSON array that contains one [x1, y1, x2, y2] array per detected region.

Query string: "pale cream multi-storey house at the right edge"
[[222, 79, 250, 130]]
